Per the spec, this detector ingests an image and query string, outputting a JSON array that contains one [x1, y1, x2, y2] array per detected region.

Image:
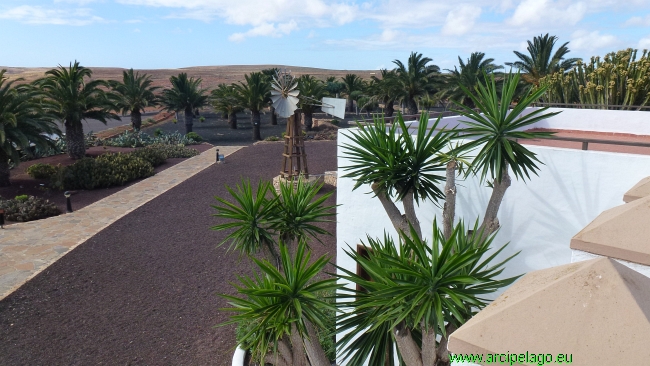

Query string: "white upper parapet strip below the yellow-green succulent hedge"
[[411, 108, 650, 135]]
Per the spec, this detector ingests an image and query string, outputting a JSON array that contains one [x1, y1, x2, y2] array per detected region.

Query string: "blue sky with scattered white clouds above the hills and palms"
[[0, 0, 650, 69]]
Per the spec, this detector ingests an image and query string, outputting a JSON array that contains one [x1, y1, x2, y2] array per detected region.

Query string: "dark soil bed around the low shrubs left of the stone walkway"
[[0, 144, 213, 219]]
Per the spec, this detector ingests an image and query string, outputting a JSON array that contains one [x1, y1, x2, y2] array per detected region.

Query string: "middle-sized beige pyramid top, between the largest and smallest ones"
[[570, 196, 650, 264]]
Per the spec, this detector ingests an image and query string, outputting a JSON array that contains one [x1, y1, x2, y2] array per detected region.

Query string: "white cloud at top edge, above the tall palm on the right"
[[508, 0, 587, 27]]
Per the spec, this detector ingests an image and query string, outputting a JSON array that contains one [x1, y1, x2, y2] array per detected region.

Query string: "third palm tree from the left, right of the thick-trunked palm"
[[109, 69, 160, 131]]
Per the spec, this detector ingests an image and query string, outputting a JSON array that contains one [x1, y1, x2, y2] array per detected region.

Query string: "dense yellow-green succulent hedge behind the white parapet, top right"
[[539, 48, 650, 110]]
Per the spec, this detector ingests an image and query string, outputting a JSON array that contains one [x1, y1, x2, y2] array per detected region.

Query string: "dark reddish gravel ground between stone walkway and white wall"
[[0, 141, 336, 365]]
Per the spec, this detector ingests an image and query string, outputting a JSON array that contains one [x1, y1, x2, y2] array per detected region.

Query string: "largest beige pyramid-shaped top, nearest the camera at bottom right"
[[448, 258, 650, 366]]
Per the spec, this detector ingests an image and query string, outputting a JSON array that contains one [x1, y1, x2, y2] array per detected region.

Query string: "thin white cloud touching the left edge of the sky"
[[0, 5, 106, 26]]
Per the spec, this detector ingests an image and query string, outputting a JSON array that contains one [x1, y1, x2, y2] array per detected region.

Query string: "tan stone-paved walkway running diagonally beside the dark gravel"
[[0, 146, 242, 300]]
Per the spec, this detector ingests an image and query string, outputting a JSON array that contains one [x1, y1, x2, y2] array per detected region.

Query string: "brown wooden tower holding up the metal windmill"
[[280, 109, 309, 181]]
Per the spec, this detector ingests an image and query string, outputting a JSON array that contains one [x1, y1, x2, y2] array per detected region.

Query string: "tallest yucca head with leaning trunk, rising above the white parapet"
[[456, 72, 560, 234]]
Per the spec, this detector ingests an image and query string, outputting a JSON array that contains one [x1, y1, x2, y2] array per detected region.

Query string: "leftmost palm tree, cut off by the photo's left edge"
[[0, 70, 61, 187]]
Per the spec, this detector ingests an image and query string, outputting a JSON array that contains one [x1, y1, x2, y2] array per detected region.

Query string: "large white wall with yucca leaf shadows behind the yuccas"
[[336, 129, 650, 364]]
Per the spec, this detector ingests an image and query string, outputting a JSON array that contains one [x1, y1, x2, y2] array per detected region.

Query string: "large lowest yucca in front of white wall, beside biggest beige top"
[[337, 221, 518, 366]]
